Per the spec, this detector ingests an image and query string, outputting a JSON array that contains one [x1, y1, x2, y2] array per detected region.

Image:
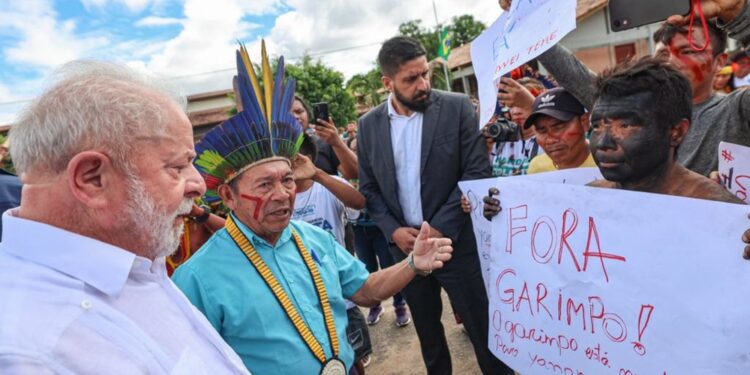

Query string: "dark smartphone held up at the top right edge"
[[609, 0, 690, 31]]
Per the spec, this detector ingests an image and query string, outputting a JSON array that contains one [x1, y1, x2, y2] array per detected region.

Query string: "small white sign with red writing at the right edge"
[[719, 142, 750, 203]]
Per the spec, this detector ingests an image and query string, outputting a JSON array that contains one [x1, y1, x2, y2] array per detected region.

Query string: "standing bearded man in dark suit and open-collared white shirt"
[[357, 37, 512, 374]]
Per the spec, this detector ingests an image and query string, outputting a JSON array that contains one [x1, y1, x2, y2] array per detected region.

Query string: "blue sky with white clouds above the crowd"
[[0, 0, 500, 124]]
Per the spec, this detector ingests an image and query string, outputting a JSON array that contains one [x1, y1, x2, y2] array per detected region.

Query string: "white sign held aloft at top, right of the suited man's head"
[[471, 0, 576, 126]]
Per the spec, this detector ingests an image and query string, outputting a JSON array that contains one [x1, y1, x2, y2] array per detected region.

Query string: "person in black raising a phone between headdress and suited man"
[[292, 95, 357, 180]]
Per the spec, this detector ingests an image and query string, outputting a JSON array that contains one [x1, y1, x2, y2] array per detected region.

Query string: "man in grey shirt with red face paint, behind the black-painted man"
[[501, 0, 750, 175]]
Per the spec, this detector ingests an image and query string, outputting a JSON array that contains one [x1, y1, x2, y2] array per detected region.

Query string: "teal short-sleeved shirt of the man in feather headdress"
[[172, 217, 369, 375]]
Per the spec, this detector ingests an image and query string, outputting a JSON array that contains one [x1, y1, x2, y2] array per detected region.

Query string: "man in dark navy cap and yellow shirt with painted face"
[[523, 88, 596, 174]]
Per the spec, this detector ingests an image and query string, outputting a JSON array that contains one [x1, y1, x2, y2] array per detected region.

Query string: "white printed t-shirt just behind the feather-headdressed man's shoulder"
[[292, 176, 359, 247]]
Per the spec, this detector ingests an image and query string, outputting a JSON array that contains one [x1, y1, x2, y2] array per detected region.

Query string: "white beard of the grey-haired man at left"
[[123, 173, 193, 259]]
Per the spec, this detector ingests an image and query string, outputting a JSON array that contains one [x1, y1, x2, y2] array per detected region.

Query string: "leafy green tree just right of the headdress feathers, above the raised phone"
[[286, 56, 357, 127]]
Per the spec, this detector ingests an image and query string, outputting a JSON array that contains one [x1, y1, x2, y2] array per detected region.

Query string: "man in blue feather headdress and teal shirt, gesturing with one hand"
[[173, 47, 452, 375]]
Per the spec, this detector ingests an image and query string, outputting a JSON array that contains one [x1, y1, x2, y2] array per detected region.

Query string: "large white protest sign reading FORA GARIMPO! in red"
[[489, 179, 750, 375]]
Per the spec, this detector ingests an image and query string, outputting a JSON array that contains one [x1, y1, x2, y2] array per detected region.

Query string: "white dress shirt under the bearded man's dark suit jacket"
[[388, 94, 424, 227]]
